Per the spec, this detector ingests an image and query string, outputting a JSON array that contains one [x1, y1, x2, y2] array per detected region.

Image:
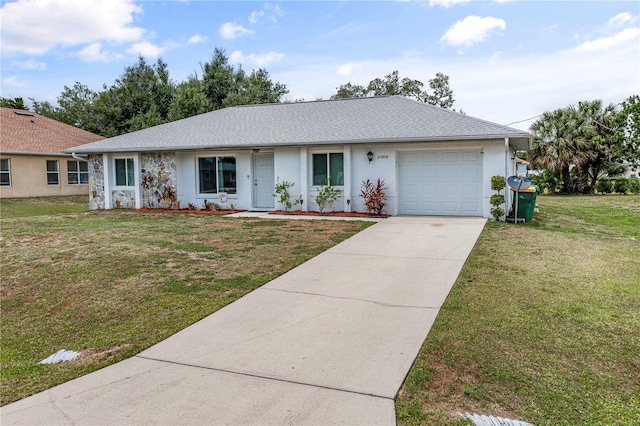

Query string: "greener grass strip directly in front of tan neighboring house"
[[0, 195, 89, 219]]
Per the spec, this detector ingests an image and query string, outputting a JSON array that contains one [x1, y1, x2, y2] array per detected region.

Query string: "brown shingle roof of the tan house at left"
[[0, 108, 104, 153]]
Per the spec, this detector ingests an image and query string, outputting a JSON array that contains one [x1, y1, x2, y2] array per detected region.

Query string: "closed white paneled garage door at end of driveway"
[[399, 151, 482, 216]]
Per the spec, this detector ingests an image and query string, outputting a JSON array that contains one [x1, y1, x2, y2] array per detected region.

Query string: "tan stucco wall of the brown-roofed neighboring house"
[[0, 153, 89, 198]]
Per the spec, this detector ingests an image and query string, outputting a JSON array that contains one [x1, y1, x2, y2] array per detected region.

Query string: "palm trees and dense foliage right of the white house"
[[527, 95, 640, 194]]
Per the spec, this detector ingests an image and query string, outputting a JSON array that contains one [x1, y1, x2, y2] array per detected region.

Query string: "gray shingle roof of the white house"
[[67, 96, 530, 153]]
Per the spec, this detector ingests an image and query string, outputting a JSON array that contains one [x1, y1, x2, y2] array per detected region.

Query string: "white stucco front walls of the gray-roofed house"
[[94, 139, 515, 217]]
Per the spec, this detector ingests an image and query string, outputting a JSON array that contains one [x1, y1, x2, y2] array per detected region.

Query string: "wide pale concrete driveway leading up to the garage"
[[1, 217, 485, 425]]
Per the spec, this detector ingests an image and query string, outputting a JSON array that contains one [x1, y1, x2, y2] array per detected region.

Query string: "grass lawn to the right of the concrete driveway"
[[396, 195, 640, 425]]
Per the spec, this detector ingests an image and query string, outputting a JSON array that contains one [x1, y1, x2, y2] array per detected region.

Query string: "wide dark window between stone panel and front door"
[[198, 157, 237, 194]]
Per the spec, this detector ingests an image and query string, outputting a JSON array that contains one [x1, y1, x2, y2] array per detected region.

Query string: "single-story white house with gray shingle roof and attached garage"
[[67, 97, 531, 217]]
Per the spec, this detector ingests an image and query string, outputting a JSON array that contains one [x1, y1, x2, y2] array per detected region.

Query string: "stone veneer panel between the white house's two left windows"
[[140, 152, 178, 208]]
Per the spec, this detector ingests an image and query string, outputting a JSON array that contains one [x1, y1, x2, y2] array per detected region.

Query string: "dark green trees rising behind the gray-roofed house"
[[0, 48, 453, 137]]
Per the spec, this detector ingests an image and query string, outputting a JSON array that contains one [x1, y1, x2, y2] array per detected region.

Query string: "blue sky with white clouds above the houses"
[[0, 0, 640, 130]]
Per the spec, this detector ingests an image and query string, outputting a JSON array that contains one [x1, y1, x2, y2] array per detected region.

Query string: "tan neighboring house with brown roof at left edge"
[[0, 108, 104, 198]]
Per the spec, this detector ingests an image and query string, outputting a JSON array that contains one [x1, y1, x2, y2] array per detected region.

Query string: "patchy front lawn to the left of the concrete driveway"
[[0, 208, 371, 405]]
